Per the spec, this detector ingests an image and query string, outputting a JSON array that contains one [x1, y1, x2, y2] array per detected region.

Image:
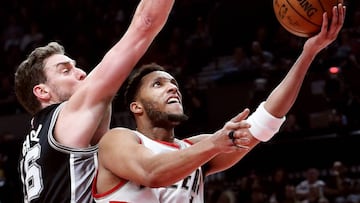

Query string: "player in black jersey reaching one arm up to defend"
[[15, 0, 174, 203]]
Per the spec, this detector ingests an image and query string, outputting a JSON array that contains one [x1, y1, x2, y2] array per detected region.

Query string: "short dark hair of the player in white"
[[124, 63, 166, 108]]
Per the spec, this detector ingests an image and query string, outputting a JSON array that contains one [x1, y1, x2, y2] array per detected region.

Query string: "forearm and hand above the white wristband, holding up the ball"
[[264, 4, 345, 118]]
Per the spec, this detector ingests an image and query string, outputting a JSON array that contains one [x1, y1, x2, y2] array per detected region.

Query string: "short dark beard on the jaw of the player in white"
[[142, 101, 188, 128]]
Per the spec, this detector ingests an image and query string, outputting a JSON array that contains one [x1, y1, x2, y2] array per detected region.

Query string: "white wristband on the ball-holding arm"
[[247, 102, 286, 142]]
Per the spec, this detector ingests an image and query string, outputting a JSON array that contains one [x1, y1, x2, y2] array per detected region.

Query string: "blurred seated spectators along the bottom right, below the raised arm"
[[206, 160, 360, 203]]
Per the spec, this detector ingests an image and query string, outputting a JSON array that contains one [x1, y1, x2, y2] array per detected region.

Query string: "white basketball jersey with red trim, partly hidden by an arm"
[[94, 131, 204, 203]]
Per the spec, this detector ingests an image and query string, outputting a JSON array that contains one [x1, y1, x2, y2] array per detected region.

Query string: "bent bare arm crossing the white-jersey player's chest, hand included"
[[96, 110, 249, 193]]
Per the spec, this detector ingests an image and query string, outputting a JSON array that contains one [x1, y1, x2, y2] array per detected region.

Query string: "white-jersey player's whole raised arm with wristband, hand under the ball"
[[202, 4, 345, 174]]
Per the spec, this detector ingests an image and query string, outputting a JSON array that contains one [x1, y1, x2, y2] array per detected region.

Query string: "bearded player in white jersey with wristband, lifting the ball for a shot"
[[93, 4, 345, 203]]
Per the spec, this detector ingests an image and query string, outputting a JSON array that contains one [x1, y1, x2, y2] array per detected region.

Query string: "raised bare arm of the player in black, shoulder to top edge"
[[55, 0, 174, 147]]
